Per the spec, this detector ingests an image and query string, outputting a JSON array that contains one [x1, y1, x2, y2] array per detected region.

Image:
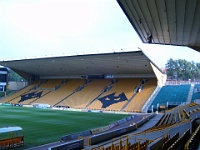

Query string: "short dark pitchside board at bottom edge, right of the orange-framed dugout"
[[48, 139, 84, 150]]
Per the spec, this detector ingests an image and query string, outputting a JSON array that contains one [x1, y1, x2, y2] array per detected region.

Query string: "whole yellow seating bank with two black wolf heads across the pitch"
[[1, 78, 157, 112]]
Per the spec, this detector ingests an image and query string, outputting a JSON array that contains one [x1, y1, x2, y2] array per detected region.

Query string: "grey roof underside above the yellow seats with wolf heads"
[[0, 51, 154, 78]]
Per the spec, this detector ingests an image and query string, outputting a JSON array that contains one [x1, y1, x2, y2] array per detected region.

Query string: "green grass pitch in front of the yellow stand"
[[0, 106, 128, 148]]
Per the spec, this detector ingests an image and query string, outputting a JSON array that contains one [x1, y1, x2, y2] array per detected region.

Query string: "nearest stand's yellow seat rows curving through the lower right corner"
[[85, 103, 200, 150]]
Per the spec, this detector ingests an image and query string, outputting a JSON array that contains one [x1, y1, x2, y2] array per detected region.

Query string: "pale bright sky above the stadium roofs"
[[0, 0, 200, 67]]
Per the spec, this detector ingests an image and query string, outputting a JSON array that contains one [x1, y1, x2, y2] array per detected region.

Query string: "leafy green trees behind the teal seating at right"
[[165, 58, 200, 80]]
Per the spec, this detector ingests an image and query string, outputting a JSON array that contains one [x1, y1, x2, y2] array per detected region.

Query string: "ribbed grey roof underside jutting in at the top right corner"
[[117, 0, 200, 52]]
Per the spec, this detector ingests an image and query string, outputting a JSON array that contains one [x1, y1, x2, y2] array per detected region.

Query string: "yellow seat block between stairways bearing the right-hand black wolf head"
[[88, 78, 141, 111]]
